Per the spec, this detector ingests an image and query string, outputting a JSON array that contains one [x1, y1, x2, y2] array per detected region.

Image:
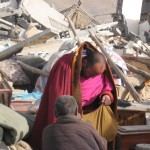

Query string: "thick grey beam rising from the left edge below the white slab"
[[0, 29, 54, 61]]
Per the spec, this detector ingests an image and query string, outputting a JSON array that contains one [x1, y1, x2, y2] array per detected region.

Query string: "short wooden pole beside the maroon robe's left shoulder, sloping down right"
[[17, 61, 49, 77]]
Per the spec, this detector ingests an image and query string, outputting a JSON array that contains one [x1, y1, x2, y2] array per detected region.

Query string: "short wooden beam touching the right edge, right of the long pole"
[[126, 63, 150, 80]]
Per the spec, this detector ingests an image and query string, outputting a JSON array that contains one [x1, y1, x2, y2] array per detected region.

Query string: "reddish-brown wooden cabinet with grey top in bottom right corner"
[[116, 125, 150, 150]]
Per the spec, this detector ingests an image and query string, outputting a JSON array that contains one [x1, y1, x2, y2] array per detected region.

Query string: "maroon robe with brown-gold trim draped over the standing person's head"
[[29, 42, 117, 150]]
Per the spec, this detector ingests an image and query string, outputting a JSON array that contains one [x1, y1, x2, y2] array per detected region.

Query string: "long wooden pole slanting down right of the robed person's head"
[[89, 31, 142, 102]]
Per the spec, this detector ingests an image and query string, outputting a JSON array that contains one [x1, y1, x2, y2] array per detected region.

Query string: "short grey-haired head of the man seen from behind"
[[55, 95, 78, 117]]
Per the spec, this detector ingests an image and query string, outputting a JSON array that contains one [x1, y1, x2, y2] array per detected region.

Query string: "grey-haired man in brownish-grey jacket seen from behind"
[[42, 95, 107, 150]]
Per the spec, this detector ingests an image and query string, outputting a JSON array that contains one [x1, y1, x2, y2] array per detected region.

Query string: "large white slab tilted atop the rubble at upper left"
[[22, 0, 68, 32]]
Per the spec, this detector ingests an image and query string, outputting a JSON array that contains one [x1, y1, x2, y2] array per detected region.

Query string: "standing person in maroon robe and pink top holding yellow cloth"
[[30, 42, 117, 150]]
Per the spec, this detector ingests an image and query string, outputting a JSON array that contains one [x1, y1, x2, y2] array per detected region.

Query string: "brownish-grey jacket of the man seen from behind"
[[42, 116, 107, 150]]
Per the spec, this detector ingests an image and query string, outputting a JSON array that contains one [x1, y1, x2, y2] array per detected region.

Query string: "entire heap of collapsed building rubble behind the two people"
[[0, 0, 150, 149]]
